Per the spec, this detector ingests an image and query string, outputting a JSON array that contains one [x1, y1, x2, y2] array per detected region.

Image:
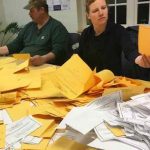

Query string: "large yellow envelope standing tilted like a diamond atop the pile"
[[52, 54, 96, 99]]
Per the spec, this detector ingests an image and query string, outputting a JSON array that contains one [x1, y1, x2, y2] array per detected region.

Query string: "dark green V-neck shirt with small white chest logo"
[[7, 17, 69, 65]]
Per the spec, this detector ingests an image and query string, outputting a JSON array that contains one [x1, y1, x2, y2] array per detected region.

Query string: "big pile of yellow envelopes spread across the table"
[[0, 54, 150, 149]]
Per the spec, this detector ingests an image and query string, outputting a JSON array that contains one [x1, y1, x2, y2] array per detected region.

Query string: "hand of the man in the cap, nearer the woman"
[[30, 55, 45, 66]]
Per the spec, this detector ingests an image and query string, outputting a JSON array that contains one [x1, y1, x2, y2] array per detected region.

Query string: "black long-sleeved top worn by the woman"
[[79, 22, 139, 75]]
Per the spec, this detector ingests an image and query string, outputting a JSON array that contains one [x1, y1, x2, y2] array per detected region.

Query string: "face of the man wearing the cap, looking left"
[[29, 7, 43, 23]]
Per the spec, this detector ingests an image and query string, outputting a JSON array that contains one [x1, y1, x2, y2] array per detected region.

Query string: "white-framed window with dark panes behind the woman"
[[80, 0, 150, 27]]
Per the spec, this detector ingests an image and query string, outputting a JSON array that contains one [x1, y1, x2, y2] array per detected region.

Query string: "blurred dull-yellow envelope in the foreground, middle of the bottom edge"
[[47, 137, 96, 150]]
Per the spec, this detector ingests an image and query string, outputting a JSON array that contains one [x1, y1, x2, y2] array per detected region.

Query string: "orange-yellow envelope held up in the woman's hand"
[[138, 25, 150, 56]]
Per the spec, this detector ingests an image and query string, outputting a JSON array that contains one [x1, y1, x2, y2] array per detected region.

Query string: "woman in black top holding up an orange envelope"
[[79, 0, 150, 75]]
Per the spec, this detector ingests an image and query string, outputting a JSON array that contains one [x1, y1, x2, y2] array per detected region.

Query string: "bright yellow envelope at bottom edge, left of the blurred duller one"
[[21, 139, 49, 150]]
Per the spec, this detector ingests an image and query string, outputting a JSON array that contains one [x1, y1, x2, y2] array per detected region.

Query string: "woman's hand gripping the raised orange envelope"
[[135, 55, 150, 68]]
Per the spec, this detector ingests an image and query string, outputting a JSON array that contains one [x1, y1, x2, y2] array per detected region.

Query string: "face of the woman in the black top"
[[87, 0, 108, 26]]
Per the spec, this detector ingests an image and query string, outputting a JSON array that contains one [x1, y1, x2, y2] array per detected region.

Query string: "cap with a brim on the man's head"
[[24, 0, 47, 10]]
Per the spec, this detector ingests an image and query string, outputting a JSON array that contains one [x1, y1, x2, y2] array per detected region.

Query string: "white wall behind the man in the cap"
[[0, 0, 80, 32]]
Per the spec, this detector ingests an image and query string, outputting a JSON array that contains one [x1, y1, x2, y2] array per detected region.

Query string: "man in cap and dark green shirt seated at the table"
[[0, 0, 69, 66]]
